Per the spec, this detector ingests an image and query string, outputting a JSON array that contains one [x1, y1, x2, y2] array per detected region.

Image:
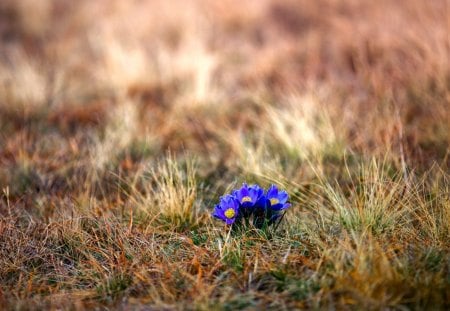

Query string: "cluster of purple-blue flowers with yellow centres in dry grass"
[[213, 183, 291, 228]]
